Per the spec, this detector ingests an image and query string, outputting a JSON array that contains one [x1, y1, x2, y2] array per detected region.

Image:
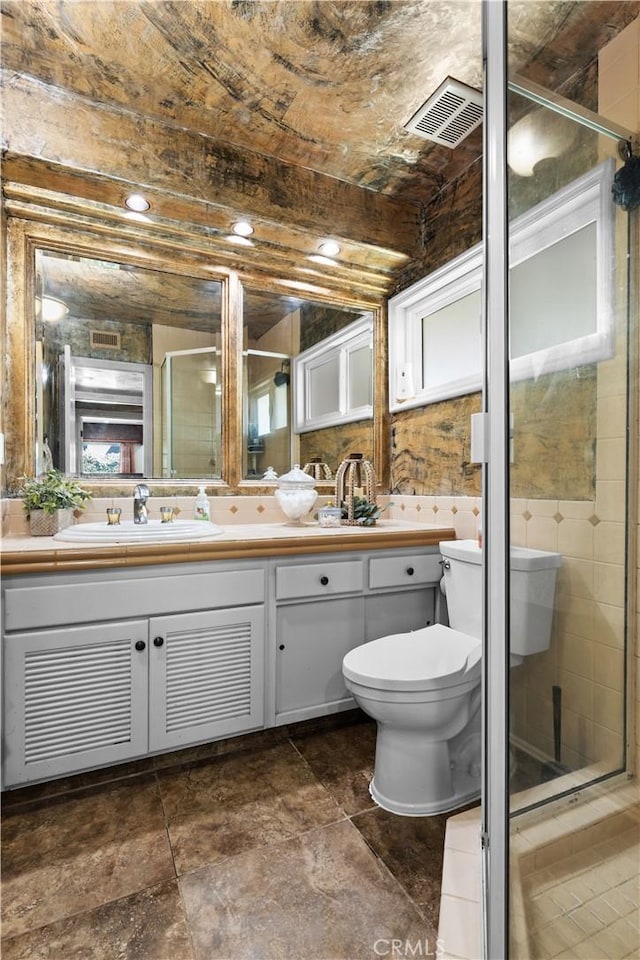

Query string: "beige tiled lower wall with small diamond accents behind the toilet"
[[389, 488, 637, 788]]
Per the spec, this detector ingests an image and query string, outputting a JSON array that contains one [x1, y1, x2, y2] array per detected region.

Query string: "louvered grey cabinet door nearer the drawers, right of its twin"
[[149, 606, 264, 750]]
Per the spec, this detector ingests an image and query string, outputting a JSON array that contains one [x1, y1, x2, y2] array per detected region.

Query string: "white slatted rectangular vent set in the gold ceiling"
[[405, 77, 482, 149]]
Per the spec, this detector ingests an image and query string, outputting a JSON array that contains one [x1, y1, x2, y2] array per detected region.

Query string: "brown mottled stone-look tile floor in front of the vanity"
[[2, 714, 460, 960]]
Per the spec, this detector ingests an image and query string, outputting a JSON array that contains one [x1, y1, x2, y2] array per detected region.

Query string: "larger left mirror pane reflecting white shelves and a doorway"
[[35, 250, 222, 479]]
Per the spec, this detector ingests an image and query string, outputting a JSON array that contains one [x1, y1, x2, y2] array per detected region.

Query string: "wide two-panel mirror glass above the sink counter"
[[34, 245, 374, 483]]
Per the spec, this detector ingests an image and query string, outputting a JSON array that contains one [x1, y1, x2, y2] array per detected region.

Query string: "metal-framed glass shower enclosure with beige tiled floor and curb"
[[482, 3, 640, 960]]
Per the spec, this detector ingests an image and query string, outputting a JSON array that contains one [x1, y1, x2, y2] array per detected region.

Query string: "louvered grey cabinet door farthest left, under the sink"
[[3, 620, 148, 786]]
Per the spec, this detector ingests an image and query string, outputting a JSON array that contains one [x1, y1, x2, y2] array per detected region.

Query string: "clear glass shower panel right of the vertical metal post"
[[506, 4, 640, 958]]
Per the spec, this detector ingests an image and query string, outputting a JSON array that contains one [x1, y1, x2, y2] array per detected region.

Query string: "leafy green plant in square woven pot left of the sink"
[[18, 470, 91, 537]]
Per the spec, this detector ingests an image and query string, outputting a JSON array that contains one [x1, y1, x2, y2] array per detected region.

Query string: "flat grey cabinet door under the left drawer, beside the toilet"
[[276, 596, 364, 723]]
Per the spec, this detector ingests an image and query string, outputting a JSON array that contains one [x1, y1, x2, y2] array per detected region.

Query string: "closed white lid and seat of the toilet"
[[342, 623, 481, 690]]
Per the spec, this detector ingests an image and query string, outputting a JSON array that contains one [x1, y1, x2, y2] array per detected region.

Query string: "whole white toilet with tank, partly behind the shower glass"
[[342, 540, 562, 817]]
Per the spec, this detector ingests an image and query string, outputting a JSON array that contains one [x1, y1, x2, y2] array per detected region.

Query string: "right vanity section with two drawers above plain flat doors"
[[275, 548, 441, 725]]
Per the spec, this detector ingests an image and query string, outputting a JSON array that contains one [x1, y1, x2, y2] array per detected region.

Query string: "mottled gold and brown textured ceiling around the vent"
[[2, 0, 640, 202]]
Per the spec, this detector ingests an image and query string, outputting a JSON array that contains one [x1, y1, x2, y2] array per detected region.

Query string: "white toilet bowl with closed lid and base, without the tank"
[[343, 624, 481, 817]]
